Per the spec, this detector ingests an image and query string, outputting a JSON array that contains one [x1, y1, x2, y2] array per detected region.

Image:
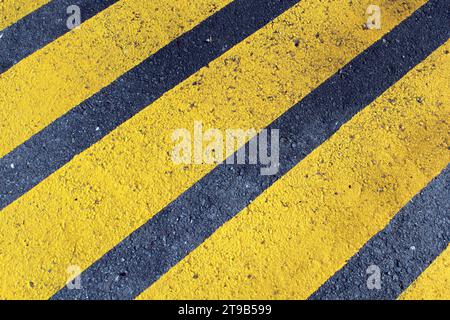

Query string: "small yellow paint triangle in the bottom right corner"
[[400, 246, 450, 300]]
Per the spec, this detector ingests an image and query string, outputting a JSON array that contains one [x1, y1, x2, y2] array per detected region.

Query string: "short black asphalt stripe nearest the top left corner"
[[0, 0, 118, 73]]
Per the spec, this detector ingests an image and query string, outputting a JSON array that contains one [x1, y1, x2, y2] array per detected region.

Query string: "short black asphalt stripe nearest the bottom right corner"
[[310, 166, 450, 300]]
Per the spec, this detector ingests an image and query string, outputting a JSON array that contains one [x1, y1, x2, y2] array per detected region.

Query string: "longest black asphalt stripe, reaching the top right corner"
[[53, 0, 450, 299]]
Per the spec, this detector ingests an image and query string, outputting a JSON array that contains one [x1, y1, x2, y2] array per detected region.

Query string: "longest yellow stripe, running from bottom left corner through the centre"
[[0, 0, 425, 298]]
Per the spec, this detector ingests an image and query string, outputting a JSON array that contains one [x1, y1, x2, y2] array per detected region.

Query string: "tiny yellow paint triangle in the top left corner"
[[0, 0, 50, 30]]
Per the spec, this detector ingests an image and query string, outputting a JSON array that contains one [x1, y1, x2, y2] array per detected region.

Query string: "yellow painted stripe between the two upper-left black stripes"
[[0, 0, 231, 157]]
